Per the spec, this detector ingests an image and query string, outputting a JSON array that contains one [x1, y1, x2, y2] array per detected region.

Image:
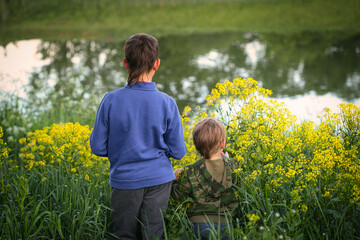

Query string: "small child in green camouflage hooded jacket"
[[172, 117, 238, 239]]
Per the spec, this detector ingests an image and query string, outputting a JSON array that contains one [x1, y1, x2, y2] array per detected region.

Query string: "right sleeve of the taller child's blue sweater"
[[164, 100, 186, 160]]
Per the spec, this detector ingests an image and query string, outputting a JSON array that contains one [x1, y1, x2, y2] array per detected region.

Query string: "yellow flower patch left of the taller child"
[[19, 123, 109, 179]]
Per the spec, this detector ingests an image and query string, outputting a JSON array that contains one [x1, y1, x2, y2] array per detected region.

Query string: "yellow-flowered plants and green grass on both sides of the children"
[[0, 78, 360, 239]]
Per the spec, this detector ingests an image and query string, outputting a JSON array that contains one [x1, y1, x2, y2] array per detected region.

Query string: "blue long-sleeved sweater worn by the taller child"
[[90, 82, 186, 189]]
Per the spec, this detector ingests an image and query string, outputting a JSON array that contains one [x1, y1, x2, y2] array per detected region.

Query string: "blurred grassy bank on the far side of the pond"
[[0, 0, 360, 45]]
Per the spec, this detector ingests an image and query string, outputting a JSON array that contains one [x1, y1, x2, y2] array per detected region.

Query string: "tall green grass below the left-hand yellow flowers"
[[0, 163, 111, 239]]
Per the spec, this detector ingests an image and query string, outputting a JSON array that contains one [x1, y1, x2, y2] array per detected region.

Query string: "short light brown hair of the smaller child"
[[192, 117, 225, 159]]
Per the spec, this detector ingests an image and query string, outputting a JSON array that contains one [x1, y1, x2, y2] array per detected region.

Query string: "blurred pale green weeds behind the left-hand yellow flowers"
[[0, 93, 97, 161]]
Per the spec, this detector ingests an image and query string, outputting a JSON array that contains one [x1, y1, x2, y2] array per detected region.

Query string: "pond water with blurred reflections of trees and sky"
[[0, 32, 360, 122]]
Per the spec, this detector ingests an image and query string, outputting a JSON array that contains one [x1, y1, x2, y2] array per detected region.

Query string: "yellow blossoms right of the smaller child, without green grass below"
[[173, 78, 360, 212]]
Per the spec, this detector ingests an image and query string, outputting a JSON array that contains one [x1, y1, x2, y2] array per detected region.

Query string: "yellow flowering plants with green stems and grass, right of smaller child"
[[169, 78, 360, 239]]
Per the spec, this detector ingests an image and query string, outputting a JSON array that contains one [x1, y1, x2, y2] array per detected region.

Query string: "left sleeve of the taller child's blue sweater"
[[90, 95, 109, 157]]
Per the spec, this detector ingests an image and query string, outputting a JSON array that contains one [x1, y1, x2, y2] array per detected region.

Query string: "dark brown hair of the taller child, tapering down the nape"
[[124, 33, 159, 86]]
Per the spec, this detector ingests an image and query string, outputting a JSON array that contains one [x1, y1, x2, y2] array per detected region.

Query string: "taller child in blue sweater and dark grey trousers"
[[90, 33, 186, 239]]
